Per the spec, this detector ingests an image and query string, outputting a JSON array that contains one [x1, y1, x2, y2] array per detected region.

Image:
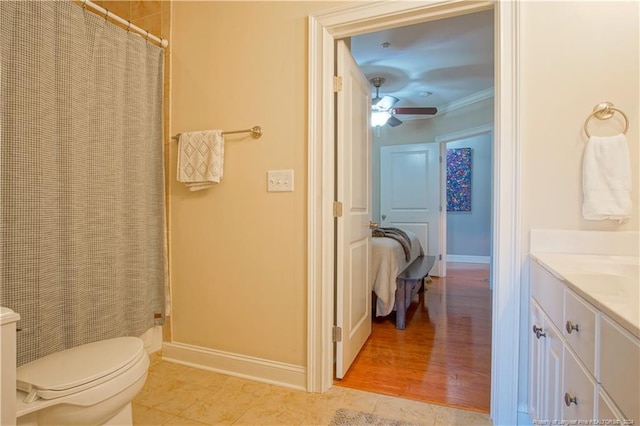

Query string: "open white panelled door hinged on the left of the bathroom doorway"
[[336, 41, 372, 379]]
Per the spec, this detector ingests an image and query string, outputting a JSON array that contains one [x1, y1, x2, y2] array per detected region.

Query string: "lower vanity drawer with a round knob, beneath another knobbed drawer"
[[561, 346, 597, 420]]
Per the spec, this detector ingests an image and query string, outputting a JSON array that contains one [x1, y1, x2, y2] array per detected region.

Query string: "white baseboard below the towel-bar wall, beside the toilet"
[[162, 342, 307, 390]]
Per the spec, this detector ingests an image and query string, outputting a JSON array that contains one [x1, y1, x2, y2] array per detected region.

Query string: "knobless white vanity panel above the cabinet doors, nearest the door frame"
[[531, 262, 564, 329]]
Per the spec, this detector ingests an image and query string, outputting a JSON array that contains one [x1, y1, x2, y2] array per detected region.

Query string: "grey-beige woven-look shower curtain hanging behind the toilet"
[[0, 0, 167, 365]]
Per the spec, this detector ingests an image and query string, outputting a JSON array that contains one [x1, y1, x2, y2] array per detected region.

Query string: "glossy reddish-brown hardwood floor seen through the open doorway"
[[335, 263, 491, 413]]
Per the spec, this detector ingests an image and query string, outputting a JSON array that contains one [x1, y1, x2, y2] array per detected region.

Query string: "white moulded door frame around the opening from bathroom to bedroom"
[[307, 0, 526, 424]]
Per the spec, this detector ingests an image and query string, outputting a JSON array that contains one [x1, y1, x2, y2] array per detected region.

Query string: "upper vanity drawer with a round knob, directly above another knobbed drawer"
[[562, 289, 598, 377]]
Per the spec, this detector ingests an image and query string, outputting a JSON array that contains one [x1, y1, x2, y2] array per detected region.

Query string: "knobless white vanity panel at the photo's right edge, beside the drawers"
[[600, 315, 640, 422]]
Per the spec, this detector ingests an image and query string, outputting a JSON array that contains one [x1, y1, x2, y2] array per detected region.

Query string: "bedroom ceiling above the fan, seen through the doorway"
[[351, 10, 494, 121]]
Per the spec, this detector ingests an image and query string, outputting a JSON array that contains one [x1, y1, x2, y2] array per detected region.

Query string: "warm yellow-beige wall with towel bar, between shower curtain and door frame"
[[170, 2, 344, 366]]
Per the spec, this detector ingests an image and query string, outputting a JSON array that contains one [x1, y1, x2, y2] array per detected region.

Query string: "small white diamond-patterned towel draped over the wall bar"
[[178, 130, 224, 191]]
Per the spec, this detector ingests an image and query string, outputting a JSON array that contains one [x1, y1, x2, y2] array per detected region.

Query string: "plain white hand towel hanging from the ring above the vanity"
[[582, 134, 631, 222]]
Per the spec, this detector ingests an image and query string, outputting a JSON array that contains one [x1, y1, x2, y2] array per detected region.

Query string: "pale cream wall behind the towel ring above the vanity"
[[520, 1, 640, 240]]
